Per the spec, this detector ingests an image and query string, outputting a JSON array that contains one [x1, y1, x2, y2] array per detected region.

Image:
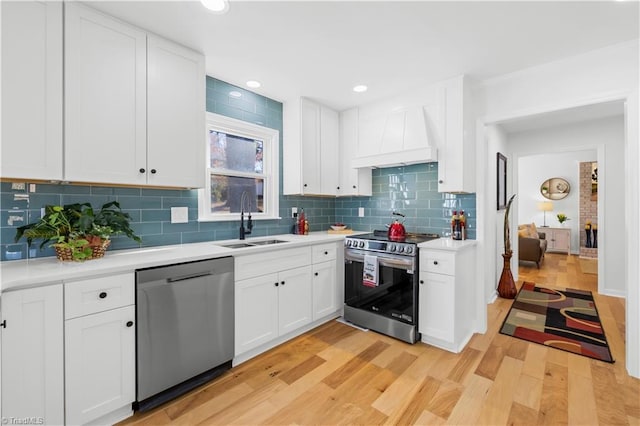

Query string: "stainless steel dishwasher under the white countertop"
[[134, 257, 234, 411]]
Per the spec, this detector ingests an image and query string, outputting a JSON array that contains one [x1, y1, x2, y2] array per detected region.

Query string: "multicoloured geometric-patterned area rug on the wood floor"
[[500, 282, 614, 362]]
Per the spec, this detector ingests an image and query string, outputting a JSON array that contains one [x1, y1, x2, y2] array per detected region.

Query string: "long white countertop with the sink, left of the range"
[[0, 232, 345, 292]]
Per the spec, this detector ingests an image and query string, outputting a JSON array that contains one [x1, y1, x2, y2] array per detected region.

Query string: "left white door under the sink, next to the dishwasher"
[[235, 274, 280, 356]]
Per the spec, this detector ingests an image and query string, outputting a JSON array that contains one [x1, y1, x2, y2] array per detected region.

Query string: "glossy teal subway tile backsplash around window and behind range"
[[0, 77, 476, 261]]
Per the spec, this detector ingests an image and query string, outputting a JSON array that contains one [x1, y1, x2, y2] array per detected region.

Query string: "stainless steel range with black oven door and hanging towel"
[[344, 231, 439, 343]]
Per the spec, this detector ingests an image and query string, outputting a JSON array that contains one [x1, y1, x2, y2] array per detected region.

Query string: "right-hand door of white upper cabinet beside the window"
[[320, 106, 340, 195]]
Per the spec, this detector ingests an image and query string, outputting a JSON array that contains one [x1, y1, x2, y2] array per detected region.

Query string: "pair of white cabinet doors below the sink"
[[235, 266, 312, 355]]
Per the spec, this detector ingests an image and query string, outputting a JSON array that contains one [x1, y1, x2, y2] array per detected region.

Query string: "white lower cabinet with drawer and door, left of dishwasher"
[[64, 273, 136, 425]]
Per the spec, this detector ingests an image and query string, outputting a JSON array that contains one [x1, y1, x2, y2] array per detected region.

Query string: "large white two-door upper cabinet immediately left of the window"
[[64, 3, 206, 187]]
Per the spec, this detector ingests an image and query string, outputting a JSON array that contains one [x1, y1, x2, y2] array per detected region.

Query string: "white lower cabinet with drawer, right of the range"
[[418, 245, 475, 353]]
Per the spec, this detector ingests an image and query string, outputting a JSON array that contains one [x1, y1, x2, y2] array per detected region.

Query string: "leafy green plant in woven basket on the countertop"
[[15, 201, 141, 261]]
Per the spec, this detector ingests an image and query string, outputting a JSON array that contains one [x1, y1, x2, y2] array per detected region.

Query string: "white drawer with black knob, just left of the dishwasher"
[[64, 273, 135, 319]]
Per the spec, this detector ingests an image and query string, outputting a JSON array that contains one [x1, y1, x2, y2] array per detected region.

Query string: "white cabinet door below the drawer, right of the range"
[[418, 271, 455, 343]]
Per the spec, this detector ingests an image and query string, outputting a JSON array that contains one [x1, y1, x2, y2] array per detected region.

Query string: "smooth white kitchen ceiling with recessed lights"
[[88, 0, 640, 110]]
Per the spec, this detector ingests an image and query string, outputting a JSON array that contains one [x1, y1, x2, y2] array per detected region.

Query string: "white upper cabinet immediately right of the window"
[[283, 98, 339, 196]]
